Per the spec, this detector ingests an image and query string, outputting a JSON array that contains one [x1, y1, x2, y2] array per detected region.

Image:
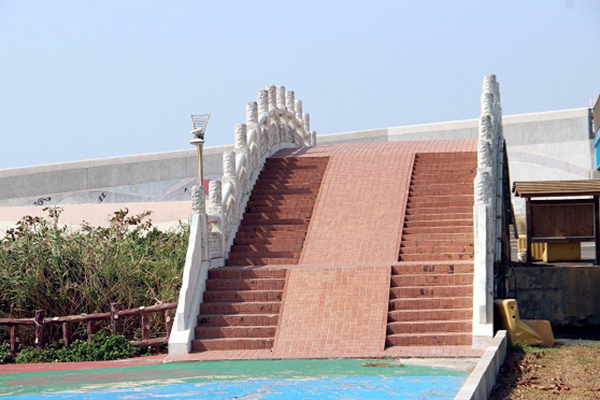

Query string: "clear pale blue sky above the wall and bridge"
[[0, 0, 600, 169]]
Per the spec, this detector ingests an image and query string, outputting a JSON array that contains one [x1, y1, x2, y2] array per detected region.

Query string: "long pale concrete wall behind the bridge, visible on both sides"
[[0, 108, 595, 211]]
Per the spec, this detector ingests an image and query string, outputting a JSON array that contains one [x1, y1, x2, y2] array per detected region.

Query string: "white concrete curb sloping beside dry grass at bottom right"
[[454, 331, 508, 400]]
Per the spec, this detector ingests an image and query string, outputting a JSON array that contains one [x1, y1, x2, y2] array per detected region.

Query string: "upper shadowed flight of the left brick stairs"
[[225, 157, 329, 266]]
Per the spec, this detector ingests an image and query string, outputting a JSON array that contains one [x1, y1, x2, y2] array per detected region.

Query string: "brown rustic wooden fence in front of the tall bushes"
[[0, 302, 177, 355]]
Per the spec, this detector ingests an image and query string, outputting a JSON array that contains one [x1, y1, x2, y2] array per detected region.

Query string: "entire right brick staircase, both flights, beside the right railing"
[[386, 153, 477, 347]]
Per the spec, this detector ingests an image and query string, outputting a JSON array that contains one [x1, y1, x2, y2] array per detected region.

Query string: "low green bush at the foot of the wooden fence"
[[15, 333, 149, 364]]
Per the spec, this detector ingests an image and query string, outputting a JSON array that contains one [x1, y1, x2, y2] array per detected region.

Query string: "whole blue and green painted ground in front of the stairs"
[[0, 359, 468, 399]]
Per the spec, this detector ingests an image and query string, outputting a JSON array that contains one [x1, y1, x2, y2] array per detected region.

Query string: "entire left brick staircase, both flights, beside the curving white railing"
[[192, 157, 328, 351]]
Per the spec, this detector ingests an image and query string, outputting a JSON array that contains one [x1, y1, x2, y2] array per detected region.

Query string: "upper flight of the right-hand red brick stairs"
[[399, 153, 477, 261]]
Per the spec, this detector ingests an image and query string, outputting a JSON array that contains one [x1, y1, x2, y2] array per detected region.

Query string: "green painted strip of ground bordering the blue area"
[[0, 359, 468, 396]]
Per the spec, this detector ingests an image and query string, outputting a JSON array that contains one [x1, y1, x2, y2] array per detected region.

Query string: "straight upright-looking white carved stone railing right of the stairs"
[[473, 75, 512, 348]]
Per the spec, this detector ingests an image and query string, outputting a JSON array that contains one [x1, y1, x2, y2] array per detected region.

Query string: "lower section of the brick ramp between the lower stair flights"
[[273, 266, 390, 358]]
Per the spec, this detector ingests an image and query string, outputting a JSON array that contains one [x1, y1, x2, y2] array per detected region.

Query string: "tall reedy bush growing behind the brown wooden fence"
[[0, 207, 189, 337]]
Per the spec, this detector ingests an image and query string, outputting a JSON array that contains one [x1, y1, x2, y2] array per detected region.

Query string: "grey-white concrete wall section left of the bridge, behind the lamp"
[[0, 146, 233, 207]]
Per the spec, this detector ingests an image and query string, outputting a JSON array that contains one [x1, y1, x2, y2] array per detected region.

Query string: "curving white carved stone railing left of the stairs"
[[169, 85, 316, 354]]
